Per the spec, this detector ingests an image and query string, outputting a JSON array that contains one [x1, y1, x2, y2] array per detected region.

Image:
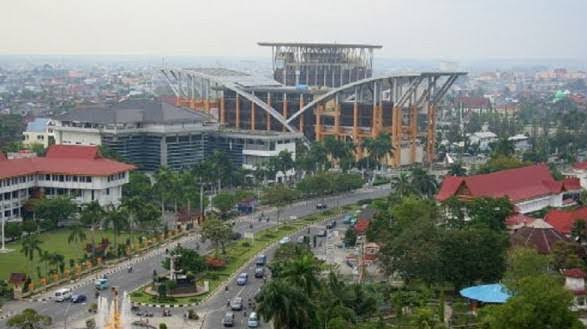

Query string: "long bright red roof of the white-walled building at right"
[[436, 164, 563, 202]]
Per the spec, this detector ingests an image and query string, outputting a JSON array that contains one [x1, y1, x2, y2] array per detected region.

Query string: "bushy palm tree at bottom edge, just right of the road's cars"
[[256, 279, 316, 329]]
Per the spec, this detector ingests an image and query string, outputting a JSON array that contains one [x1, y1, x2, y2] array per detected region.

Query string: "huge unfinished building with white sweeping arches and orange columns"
[[161, 42, 466, 167]]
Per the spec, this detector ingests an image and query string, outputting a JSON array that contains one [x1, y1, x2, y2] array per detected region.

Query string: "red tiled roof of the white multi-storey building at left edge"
[[0, 146, 136, 178]]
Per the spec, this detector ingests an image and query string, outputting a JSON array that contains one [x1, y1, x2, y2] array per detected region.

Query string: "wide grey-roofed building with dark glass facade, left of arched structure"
[[54, 100, 303, 173]]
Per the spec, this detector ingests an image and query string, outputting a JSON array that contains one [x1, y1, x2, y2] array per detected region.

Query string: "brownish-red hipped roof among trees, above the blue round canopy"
[[510, 226, 570, 254]]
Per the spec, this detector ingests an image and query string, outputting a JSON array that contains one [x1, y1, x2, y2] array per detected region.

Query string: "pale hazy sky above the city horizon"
[[0, 0, 587, 60]]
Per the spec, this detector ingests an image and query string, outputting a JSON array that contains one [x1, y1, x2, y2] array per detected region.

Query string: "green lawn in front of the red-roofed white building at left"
[[0, 229, 134, 280]]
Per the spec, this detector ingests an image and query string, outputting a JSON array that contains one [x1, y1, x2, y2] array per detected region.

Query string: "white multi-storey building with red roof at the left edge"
[[0, 145, 135, 221]]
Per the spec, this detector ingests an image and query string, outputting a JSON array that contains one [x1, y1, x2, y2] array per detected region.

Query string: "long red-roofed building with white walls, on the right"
[[436, 164, 580, 214]]
